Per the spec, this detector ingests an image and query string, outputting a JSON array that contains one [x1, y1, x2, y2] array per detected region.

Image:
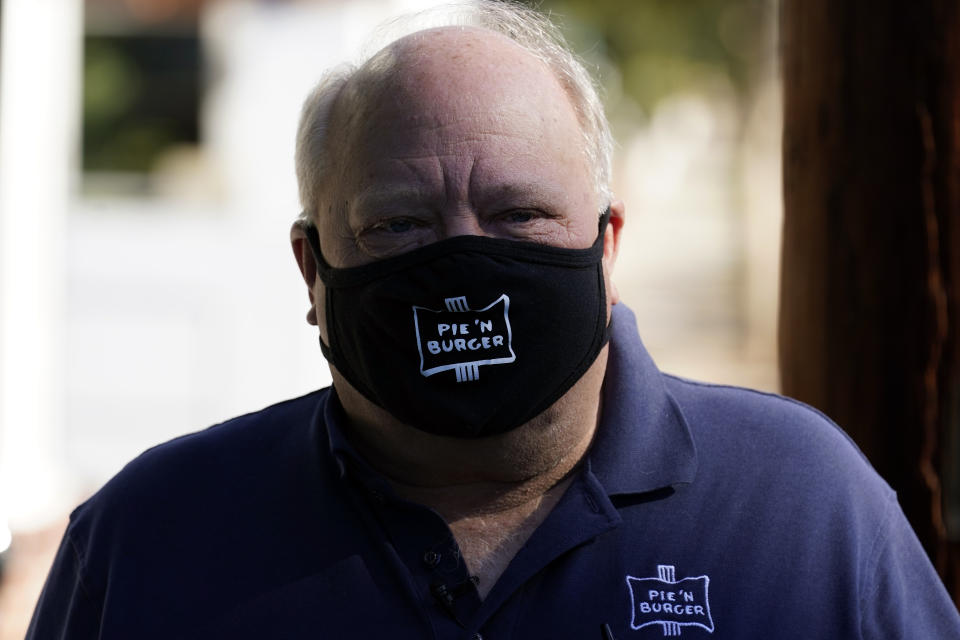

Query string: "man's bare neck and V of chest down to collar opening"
[[331, 349, 607, 598]]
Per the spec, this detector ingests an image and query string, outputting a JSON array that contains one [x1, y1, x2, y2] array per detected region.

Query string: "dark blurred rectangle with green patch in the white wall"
[[83, 34, 200, 173]]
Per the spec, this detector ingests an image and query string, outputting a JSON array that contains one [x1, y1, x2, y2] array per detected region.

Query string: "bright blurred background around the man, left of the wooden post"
[[0, 0, 781, 640]]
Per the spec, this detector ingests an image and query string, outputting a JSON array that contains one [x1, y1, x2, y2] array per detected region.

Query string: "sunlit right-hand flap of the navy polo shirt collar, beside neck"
[[588, 304, 697, 495]]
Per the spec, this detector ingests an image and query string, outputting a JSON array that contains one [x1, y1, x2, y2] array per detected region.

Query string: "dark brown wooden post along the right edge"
[[779, 0, 960, 602]]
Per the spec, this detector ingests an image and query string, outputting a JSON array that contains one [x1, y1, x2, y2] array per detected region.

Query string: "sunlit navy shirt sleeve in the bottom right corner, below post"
[[860, 497, 960, 640]]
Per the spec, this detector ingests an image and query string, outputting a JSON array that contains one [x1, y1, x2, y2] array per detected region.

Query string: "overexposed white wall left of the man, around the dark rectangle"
[[0, 0, 464, 538]]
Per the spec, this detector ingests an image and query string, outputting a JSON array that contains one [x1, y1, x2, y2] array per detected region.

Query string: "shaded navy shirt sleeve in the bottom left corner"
[[26, 528, 102, 640]]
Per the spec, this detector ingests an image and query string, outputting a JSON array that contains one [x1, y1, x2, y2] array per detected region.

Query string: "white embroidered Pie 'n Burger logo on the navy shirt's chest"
[[627, 564, 713, 636]]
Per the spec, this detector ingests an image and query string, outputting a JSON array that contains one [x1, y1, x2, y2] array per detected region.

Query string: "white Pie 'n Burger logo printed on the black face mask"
[[413, 294, 517, 382]]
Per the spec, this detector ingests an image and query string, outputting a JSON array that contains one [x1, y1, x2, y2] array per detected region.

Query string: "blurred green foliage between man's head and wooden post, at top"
[[526, 0, 775, 114]]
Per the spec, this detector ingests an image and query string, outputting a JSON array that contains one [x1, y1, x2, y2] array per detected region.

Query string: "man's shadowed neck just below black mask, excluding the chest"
[[331, 349, 606, 522]]
